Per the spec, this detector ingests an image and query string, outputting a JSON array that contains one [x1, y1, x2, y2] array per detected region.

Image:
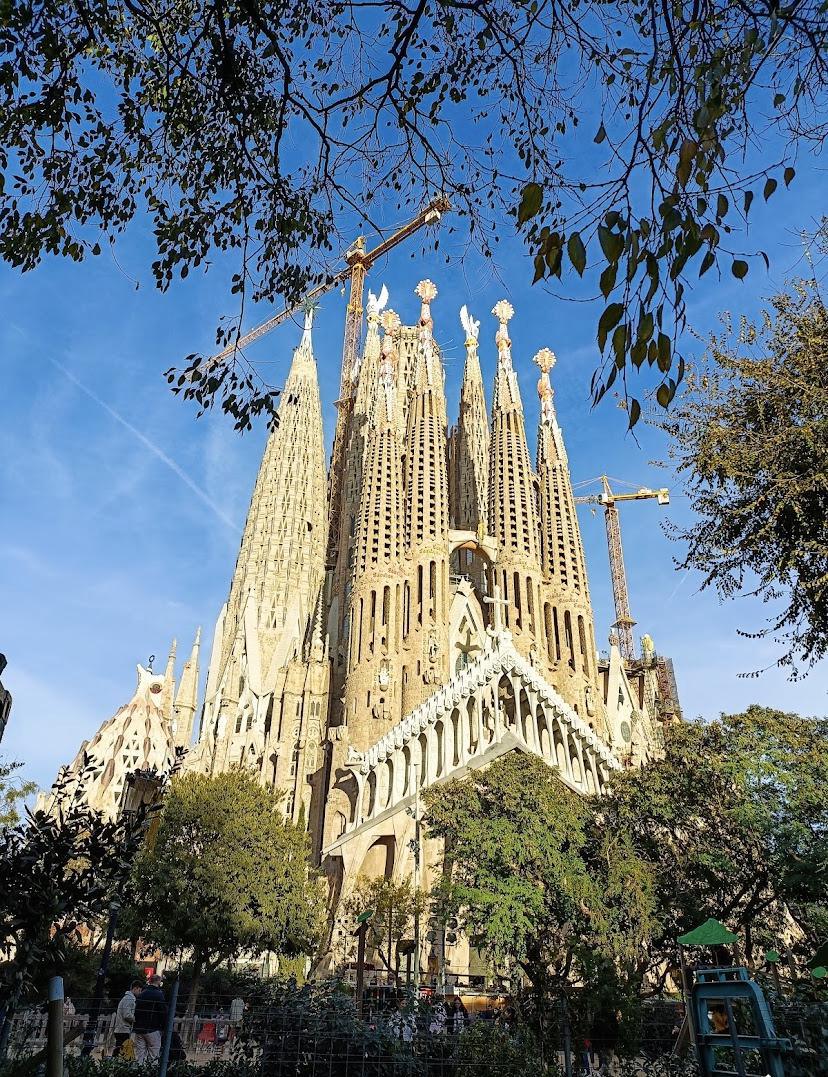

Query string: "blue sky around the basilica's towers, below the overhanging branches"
[[0, 154, 828, 785]]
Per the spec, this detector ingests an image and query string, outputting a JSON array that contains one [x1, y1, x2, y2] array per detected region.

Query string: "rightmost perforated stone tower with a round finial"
[[534, 348, 606, 732]]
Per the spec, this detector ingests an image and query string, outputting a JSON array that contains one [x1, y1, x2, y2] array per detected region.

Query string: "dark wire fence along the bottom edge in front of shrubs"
[[3, 985, 828, 1077]]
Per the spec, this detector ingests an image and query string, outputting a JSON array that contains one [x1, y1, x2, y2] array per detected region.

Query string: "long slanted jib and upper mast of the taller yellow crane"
[[202, 196, 451, 377]]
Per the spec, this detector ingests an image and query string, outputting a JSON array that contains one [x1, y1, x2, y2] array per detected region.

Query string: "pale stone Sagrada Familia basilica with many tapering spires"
[[48, 280, 679, 956]]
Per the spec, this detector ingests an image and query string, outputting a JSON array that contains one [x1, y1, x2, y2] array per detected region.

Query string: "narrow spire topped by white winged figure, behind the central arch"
[[451, 307, 491, 531]]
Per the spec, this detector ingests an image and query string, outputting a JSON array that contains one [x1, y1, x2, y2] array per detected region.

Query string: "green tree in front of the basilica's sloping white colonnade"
[[425, 753, 652, 993]]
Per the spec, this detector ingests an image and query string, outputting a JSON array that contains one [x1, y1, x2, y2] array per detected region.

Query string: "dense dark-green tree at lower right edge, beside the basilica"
[[600, 707, 828, 960]]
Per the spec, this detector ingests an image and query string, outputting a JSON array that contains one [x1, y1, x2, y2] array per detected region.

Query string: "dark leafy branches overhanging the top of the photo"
[[0, 0, 828, 425]]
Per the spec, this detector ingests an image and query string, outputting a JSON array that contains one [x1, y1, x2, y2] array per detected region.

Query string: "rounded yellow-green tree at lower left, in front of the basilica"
[[125, 770, 322, 1005]]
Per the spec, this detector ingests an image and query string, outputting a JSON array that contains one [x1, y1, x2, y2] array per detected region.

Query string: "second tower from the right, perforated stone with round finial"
[[489, 299, 542, 657]]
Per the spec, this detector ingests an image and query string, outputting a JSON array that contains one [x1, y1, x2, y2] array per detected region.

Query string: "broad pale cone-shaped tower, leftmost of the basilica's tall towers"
[[201, 311, 327, 773]]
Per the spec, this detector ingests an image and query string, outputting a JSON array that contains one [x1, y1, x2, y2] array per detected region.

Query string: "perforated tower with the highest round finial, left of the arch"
[[402, 280, 449, 713]]
